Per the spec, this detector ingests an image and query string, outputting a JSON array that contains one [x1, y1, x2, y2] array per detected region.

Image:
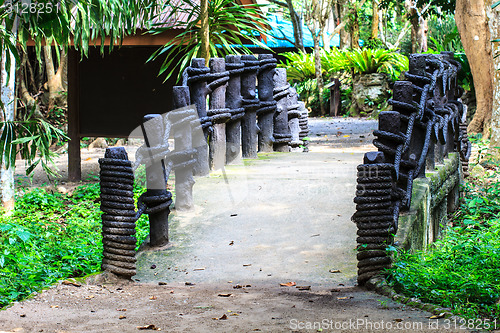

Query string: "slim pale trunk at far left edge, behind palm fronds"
[[0, 42, 16, 212]]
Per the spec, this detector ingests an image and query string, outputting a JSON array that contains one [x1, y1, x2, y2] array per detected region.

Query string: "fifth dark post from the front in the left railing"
[[208, 58, 231, 170]]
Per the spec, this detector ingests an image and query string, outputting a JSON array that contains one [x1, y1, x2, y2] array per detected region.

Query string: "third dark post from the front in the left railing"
[[172, 86, 198, 211]]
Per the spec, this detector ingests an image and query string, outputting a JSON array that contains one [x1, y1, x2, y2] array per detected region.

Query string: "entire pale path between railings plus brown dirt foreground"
[[0, 119, 460, 333]]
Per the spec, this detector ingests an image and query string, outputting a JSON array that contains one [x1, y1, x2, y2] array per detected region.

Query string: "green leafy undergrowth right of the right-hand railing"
[[388, 142, 500, 321]]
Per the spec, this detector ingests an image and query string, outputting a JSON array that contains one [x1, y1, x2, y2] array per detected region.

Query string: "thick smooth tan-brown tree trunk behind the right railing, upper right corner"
[[455, 0, 494, 137]]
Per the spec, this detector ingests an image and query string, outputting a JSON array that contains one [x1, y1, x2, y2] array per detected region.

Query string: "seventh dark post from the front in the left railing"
[[241, 55, 259, 158]]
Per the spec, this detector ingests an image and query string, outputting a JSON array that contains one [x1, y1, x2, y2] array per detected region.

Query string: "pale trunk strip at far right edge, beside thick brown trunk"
[[485, 0, 500, 149]]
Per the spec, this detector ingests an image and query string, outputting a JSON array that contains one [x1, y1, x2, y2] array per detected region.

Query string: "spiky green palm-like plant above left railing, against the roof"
[[150, 0, 268, 80]]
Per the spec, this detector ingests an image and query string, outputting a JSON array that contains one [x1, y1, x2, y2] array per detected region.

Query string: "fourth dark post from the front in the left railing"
[[187, 58, 212, 176]]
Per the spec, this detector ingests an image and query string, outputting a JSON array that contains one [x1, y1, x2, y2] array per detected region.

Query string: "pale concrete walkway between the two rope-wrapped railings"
[[135, 116, 376, 287]]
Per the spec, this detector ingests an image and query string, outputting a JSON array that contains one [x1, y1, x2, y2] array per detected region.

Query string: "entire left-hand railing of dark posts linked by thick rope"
[[99, 54, 309, 277]]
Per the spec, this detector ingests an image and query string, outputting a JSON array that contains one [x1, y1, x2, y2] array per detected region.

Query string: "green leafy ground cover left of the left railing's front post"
[[0, 182, 149, 308]]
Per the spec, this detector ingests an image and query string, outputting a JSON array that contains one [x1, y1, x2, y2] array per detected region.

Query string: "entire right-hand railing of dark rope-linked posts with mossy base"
[[352, 52, 470, 285]]
